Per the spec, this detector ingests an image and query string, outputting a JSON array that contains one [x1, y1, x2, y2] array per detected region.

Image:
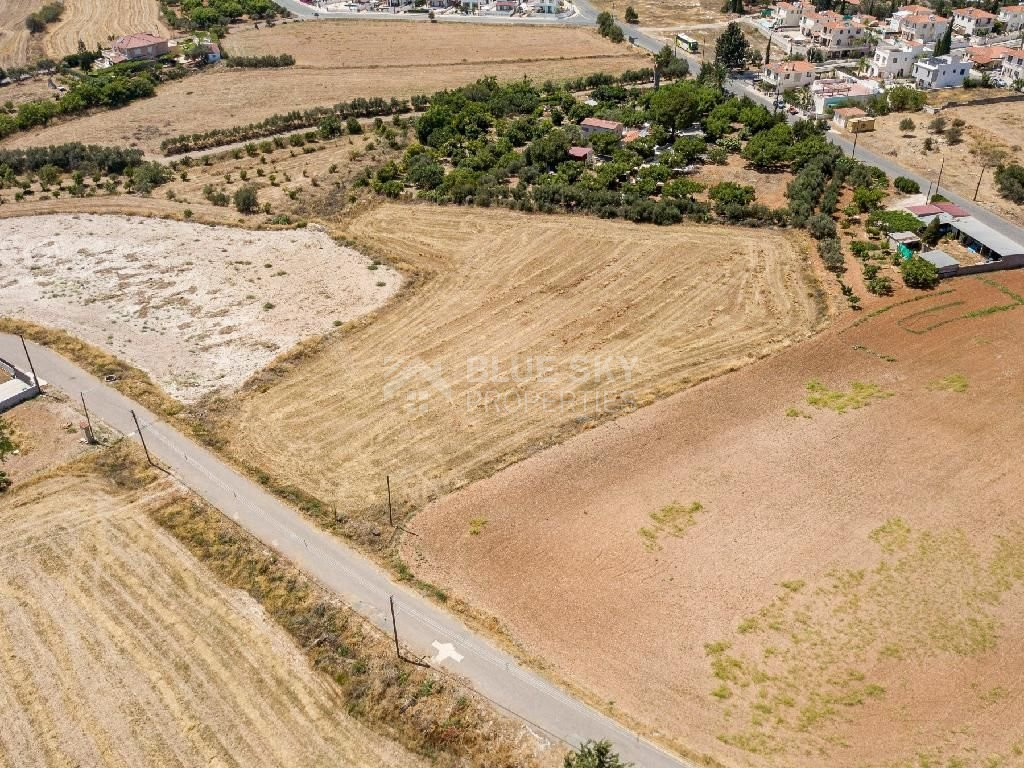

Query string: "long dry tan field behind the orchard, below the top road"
[[3, 22, 650, 155]]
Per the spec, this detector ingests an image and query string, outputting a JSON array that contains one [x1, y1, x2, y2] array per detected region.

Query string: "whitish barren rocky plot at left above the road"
[[0, 214, 400, 401]]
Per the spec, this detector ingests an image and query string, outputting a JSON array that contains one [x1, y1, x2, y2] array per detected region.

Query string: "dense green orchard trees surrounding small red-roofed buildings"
[[360, 78, 820, 225]]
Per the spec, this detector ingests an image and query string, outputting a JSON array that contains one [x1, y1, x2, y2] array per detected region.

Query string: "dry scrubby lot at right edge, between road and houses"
[[860, 101, 1024, 231]]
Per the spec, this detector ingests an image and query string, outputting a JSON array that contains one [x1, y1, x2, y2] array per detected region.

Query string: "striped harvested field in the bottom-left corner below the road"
[[0, 444, 422, 768]]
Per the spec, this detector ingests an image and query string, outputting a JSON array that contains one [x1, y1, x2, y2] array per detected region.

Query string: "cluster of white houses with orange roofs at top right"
[[759, 0, 1024, 96]]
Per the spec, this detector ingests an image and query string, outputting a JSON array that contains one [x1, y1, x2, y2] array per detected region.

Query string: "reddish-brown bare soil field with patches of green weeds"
[[403, 271, 1024, 768]]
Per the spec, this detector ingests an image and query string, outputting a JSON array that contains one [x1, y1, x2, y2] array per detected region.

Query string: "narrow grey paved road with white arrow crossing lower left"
[[0, 334, 688, 768]]
